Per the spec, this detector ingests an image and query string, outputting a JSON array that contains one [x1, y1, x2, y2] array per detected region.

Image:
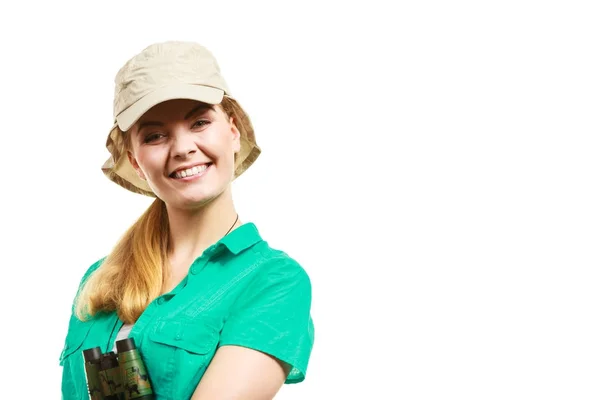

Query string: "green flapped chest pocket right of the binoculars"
[[142, 320, 219, 399]]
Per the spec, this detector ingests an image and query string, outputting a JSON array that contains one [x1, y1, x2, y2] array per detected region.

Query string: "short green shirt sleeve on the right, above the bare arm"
[[219, 259, 314, 383]]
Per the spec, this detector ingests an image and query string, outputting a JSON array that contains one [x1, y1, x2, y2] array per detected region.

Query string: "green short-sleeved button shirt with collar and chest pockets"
[[60, 223, 314, 400]]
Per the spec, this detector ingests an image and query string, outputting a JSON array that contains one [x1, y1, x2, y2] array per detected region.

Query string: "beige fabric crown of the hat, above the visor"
[[113, 41, 230, 118]]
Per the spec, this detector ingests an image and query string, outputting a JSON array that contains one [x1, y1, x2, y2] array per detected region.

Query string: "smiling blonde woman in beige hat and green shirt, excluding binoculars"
[[60, 42, 314, 400]]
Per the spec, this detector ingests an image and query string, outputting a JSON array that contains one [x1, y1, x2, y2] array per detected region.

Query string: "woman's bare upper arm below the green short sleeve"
[[192, 346, 290, 400]]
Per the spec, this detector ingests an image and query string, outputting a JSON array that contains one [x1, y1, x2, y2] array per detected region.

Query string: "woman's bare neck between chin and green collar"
[[167, 188, 241, 260]]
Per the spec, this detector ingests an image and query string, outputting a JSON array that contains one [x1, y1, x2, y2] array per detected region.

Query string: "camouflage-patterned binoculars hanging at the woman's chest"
[[83, 338, 154, 400]]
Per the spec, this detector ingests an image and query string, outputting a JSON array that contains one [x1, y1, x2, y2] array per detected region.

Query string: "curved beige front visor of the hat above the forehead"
[[116, 84, 225, 132]]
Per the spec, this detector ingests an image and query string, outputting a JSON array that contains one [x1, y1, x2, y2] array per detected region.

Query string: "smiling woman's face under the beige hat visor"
[[129, 100, 240, 209]]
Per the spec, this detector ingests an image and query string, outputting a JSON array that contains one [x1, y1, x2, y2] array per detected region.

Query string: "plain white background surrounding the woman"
[[0, 0, 600, 400]]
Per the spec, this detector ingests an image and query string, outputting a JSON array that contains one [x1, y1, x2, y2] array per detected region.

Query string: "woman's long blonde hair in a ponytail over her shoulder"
[[74, 97, 241, 324]]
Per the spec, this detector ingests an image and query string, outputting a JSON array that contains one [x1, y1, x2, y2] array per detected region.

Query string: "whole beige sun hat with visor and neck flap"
[[102, 41, 261, 197]]
